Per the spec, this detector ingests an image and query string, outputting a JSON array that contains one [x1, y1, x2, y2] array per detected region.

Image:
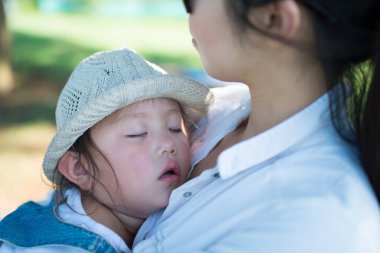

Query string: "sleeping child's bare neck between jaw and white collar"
[[82, 196, 144, 247]]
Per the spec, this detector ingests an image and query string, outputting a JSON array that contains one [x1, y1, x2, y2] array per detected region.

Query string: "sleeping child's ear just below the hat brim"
[[58, 151, 92, 191]]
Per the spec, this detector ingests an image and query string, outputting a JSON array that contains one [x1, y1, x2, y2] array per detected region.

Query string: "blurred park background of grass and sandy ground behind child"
[[0, 0, 204, 218]]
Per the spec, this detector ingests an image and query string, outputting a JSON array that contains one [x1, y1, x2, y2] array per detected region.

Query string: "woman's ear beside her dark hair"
[[250, 0, 301, 39]]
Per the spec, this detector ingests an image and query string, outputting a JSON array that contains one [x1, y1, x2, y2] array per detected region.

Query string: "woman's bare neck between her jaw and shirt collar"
[[242, 55, 326, 139]]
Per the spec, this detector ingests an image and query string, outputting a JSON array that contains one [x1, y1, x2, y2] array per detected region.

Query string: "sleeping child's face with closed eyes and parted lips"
[[91, 98, 190, 218]]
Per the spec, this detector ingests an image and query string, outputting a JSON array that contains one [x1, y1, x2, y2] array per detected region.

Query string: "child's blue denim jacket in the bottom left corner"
[[0, 201, 116, 252]]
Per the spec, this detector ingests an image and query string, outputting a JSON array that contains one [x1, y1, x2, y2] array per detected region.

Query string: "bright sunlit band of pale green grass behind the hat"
[[9, 13, 200, 67]]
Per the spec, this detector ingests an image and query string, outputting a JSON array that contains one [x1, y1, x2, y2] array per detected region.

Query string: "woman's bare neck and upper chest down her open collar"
[[189, 58, 326, 179]]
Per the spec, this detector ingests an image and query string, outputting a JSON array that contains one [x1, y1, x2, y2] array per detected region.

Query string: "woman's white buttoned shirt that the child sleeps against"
[[133, 88, 380, 253]]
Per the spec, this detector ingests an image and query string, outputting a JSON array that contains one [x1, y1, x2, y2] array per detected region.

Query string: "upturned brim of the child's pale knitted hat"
[[43, 75, 213, 183]]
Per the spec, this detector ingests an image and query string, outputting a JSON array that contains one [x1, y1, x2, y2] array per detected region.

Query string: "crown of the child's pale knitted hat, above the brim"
[[55, 49, 165, 129]]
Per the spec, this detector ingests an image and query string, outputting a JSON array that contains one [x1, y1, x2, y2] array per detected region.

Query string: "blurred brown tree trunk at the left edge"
[[0, 0, 14, 94]]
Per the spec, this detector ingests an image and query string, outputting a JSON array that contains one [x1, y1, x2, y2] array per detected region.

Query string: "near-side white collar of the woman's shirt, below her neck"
[[217, 90, 331, 179]]
